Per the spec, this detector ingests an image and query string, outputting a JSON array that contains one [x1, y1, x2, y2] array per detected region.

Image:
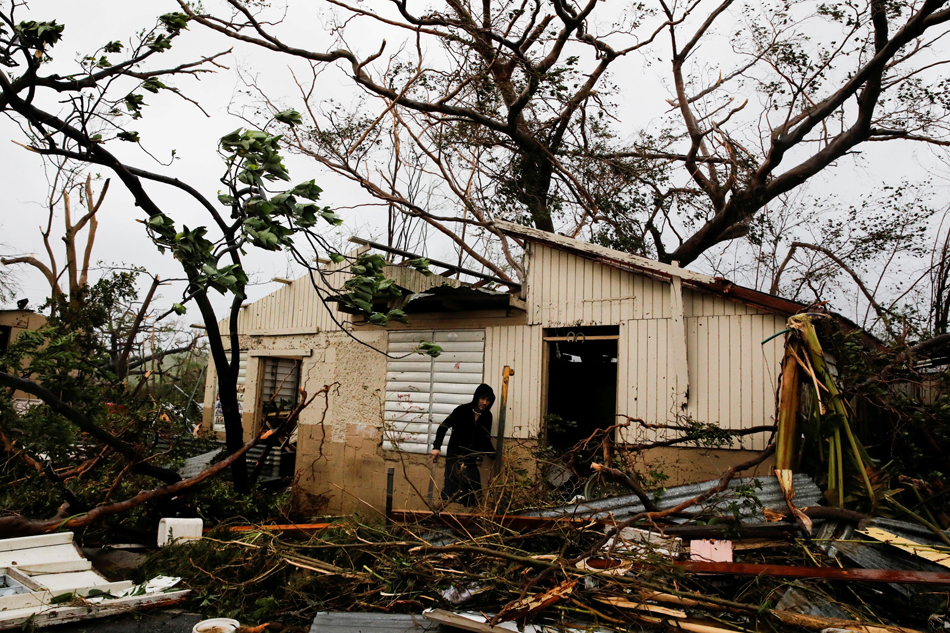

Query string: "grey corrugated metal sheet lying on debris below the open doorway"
[[525, 474, 821, 523]]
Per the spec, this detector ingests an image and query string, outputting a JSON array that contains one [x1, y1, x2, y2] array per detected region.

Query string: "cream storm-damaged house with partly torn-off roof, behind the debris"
[[205, 222, 801, 512]]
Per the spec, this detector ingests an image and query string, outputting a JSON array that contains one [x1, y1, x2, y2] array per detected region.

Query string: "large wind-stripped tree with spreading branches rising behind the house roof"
[[178, 0, 950, 278]]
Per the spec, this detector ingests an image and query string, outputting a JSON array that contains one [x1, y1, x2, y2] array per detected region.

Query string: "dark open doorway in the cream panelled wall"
[[544, 326, 619, 449]]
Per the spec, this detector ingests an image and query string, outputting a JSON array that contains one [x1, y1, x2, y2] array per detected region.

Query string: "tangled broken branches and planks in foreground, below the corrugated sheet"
[[128, 494, 950, 633]]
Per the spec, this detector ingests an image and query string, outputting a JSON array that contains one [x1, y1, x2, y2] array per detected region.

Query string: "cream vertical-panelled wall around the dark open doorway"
[[512, 243, 786, 450]]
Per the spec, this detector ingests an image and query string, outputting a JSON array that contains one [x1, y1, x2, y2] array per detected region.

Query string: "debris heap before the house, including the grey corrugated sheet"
[[139, 466, 950, 633]]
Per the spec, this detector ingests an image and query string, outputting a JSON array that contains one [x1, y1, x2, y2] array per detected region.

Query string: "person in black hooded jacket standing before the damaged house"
[[432, 383, 495, 507]]
